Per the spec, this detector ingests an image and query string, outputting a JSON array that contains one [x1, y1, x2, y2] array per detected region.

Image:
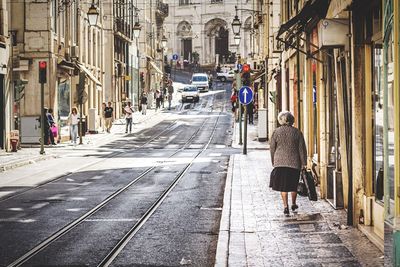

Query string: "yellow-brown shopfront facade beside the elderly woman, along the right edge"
[[267, 0, 400, 266]]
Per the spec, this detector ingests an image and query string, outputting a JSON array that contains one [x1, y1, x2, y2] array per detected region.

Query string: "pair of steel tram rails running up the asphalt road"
[[8, 107, 221, 266]]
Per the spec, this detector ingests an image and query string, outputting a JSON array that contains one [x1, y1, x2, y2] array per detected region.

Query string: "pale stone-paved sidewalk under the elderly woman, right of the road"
[[216, 149, 383, 266]]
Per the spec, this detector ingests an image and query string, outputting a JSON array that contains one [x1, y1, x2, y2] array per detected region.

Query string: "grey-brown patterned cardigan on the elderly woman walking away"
[[270, 125, 307, 170]]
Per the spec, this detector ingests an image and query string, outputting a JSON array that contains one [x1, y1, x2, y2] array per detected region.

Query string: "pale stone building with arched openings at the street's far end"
[[164, 0, 252, 66]]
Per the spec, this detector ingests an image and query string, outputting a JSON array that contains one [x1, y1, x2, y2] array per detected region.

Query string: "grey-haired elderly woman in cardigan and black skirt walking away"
[[269, 111, 307, 216]]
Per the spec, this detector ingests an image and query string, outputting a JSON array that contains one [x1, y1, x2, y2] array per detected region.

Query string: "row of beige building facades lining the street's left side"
[[0, 0, 149, 151]]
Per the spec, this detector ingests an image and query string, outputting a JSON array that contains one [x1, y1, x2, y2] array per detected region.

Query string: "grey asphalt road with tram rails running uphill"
[[0, 84, 237, 266]]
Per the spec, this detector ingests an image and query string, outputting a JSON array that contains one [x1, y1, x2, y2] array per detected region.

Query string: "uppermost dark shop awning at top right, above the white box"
[[277, 0, 331, 39]]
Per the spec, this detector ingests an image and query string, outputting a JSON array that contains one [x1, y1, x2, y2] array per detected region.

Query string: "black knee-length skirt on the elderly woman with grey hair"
[[269, 167, 300, 192]]
